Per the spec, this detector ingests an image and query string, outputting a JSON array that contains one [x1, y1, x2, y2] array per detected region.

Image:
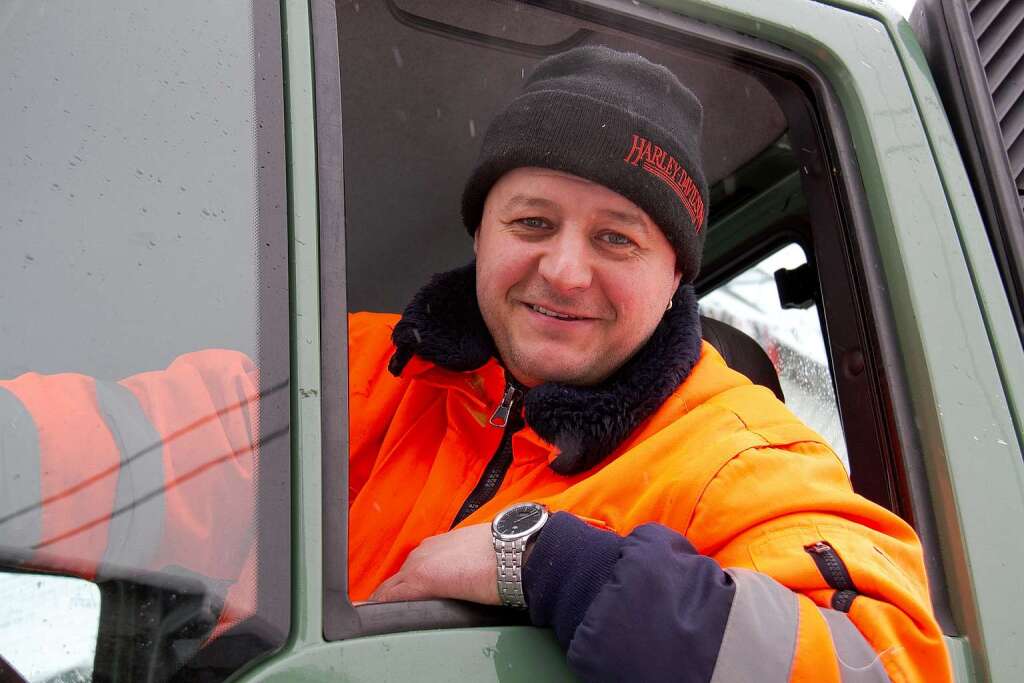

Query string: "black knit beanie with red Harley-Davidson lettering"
[[462, 46, 708, 283]]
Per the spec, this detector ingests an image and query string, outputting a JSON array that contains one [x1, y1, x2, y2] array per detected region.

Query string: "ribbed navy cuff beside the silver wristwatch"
[[522, 512, 623, 648]]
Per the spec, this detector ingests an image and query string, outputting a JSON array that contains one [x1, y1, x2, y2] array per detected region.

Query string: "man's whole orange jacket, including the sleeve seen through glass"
[[0, 313, 949, 681]]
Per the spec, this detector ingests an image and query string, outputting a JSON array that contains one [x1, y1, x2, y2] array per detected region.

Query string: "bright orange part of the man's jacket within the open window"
[[349, 313, 950, 681]]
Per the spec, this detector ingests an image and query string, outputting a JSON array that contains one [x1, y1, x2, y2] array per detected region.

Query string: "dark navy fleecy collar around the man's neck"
[[388, 263, 700, 475]]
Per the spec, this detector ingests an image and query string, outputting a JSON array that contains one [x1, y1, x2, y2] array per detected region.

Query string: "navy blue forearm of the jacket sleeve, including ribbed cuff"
[[523, 513, 735, 683]]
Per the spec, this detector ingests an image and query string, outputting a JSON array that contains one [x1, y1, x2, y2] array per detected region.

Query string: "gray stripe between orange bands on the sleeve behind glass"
[[96, 380, 165, 574]]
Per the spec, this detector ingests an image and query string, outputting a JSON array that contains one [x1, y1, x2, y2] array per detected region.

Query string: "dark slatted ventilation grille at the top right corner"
[[968, 0, 1024, 207]]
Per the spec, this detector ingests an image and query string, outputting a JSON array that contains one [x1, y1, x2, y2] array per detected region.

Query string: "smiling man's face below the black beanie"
[[473, 168, 680, 386]]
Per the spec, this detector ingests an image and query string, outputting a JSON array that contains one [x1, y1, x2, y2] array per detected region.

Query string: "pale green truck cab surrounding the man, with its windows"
[[0, 0, 1024, 682]]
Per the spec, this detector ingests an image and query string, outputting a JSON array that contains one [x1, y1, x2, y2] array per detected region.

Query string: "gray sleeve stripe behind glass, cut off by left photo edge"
[[0, 387, 43, 548]]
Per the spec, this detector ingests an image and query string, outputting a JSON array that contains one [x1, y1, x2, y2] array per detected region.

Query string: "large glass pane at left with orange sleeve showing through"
[[0, 0, 289, 680]]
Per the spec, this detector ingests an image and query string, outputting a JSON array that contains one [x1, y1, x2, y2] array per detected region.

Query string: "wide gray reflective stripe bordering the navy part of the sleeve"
[[711, 569, 800, 683]]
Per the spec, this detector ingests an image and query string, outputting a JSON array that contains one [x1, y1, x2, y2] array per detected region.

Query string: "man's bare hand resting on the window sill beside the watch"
[[370, 524, 501, 605]]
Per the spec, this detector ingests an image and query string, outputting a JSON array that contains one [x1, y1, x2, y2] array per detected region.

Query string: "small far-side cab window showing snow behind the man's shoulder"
[[700, 244, 850, 471]]
